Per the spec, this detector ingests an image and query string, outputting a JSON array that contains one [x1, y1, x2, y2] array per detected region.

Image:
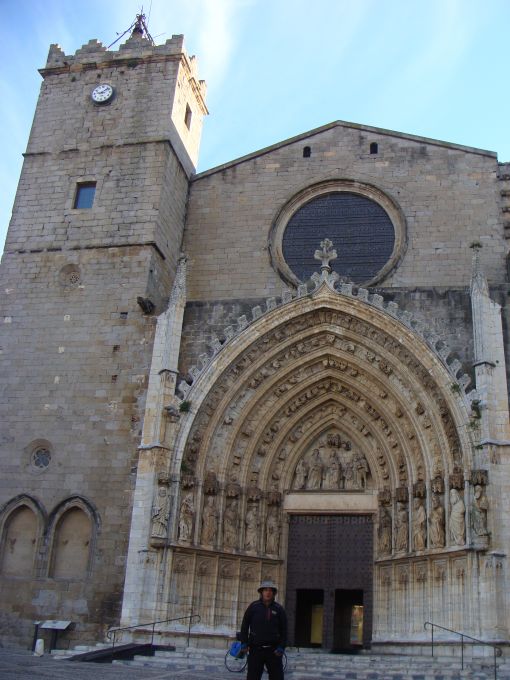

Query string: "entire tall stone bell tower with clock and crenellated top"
[[0, 17, 207, 643]]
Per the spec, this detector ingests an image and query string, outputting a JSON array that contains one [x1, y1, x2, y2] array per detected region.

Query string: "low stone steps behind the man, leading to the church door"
[[105, 647, 510, 680]]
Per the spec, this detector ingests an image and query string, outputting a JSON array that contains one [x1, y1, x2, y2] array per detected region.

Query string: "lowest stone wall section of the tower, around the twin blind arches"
[[0, 247, 170, 644]]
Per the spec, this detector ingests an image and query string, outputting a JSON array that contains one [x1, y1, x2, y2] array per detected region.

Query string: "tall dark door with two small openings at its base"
[[286, 515, 374, 651]]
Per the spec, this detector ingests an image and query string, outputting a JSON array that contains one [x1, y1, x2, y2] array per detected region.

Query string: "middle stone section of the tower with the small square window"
[[5, 142, 187, 271]]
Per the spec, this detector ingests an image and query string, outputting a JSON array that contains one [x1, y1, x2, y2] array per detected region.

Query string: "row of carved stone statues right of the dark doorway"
[[378, 485, 489, 555]]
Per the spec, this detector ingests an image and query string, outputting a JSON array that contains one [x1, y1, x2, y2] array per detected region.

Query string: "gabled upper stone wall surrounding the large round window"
[[185, 124, 506, 301]]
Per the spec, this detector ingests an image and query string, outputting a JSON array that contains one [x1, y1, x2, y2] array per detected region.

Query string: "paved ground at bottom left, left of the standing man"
[[0, 648, 229, 680]]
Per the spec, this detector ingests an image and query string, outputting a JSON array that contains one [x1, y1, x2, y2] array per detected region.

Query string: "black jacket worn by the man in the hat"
[[241, 598, 287, 648]]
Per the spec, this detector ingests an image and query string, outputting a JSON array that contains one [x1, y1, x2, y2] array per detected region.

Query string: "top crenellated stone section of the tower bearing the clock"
[[28, 36, 205, 169]]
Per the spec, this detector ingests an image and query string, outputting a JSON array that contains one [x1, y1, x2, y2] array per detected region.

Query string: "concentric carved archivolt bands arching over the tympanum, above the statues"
[[180, 312, 470, 494]]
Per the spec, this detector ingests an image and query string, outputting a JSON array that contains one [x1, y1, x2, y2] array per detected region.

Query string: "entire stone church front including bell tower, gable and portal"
[[0, 25, 510, 650]]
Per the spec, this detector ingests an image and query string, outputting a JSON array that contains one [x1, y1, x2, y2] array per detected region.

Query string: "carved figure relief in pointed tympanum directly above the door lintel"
[[292, 431, 371, 491]]
